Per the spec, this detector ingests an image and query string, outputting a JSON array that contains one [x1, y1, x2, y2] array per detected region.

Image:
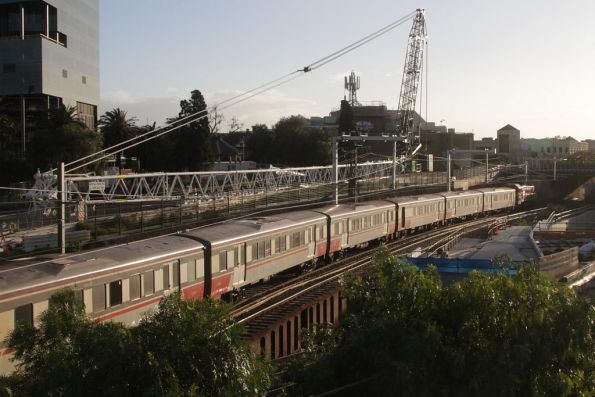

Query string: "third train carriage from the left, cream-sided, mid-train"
[[319, 200, 396, 255]]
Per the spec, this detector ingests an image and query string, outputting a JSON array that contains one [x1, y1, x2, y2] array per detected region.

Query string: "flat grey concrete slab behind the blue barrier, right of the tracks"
[[448, 226, 541, 262]]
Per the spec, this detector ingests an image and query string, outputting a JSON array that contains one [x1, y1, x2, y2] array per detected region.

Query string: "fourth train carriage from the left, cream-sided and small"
[[387, 194, 444, 233]]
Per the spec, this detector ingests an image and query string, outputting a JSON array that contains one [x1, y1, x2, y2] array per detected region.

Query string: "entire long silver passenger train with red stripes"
[[0, 185, 533, 373]]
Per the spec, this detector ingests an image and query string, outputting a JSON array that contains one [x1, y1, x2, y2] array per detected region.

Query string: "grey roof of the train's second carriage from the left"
[[184, 211, 326, 244]]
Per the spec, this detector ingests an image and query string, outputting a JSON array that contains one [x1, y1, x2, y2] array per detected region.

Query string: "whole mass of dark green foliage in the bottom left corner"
[[5, 290, 270, 396]]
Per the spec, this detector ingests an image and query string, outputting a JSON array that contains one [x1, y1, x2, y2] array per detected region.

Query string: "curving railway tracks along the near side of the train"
[[232, 208, 543, 338]]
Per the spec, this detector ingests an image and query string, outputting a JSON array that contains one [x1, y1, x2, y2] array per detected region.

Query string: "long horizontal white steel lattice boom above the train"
[[65, 161, 400, 202]]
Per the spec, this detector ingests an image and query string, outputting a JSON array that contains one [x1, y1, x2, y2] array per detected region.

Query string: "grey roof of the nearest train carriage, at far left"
[[0, 235, 204, 300]]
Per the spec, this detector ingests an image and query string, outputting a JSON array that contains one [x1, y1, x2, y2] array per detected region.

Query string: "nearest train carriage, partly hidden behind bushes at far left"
[[0, 236, 204, 373]]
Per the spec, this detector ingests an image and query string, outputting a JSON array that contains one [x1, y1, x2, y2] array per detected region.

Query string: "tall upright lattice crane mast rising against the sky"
[[397, 9, 427, 155]]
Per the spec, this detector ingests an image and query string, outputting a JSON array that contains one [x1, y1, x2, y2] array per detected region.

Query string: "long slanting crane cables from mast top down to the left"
[[62, 12, 415, 172]]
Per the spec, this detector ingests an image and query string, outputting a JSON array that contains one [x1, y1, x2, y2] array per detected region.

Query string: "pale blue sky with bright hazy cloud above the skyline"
[[100, 0, 595, 140]]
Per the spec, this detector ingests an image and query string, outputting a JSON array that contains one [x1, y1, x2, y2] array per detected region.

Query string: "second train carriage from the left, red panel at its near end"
[[184, 211, 327, 290]]
